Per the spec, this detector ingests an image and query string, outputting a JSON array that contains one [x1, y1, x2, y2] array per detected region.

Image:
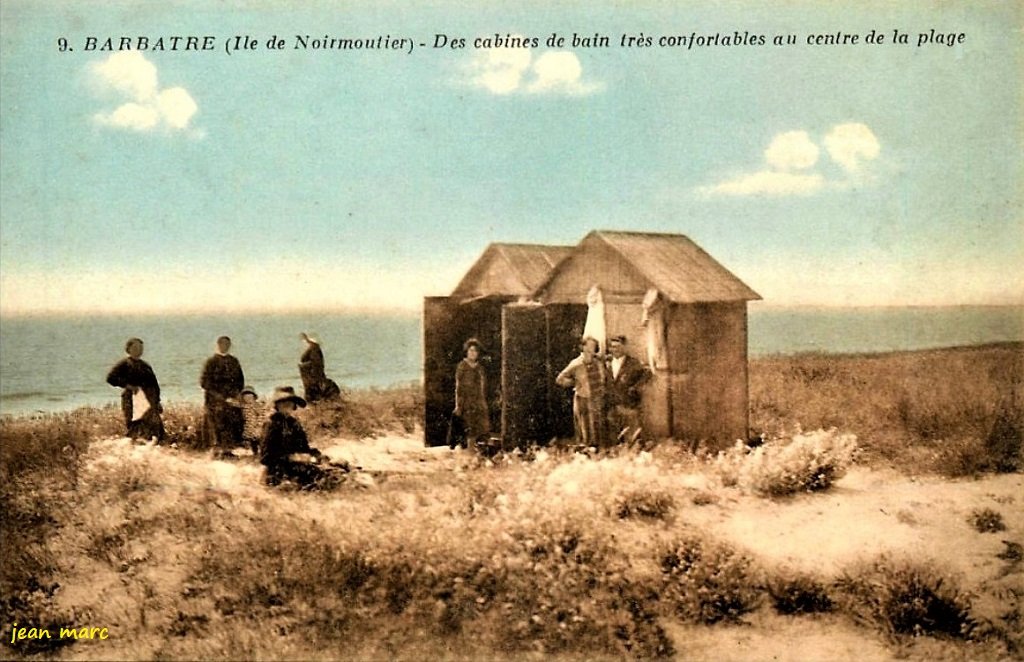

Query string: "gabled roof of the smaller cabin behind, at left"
[[452, 244, 572, 299]]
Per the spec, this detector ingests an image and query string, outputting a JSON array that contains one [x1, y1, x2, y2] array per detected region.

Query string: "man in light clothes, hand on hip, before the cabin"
[[555, 336, 605, 448]]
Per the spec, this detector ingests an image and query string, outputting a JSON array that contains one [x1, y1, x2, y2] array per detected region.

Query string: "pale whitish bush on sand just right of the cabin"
[[712, 429, 857, 497]]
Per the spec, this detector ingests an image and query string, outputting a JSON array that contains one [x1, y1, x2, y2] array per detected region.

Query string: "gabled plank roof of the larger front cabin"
[[535, 231, 761, 303]]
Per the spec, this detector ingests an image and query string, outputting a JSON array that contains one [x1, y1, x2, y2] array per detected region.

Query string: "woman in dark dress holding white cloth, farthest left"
[[106, 338, 164, 442]]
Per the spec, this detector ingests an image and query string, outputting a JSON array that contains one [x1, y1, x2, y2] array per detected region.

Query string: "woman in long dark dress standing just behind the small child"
[[199, 336, 246, 453]]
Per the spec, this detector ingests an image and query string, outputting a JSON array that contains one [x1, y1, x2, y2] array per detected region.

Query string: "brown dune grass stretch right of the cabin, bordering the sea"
[[750, 342, 1024, 477]]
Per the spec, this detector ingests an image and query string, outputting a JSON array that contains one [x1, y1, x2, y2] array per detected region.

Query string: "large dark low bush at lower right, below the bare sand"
[[837, 555, 978, 638]]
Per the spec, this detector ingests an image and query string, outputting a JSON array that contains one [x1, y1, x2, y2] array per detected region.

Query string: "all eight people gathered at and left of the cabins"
[[106, 333, 650, 486]]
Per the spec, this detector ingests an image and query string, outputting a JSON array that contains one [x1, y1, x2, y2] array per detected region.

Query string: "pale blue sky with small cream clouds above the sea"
[[0, 0, 1024, 314]]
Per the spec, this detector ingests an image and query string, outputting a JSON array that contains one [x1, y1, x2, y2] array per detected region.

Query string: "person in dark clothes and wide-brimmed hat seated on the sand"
[[260, 386, 344, 489]]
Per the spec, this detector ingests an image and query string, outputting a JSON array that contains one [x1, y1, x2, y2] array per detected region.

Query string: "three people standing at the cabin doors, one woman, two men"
[[449, 335, 650, 449]]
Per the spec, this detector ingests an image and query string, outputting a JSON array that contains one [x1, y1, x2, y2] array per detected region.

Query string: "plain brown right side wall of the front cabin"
[[667, 301, 748, 448]]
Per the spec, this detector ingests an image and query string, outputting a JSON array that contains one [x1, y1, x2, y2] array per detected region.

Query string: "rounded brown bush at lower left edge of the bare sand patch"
[[659, 536, 762, 624]]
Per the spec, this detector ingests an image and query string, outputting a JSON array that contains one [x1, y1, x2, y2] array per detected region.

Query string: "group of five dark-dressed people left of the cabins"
[[106, 333, 347, 487]]
